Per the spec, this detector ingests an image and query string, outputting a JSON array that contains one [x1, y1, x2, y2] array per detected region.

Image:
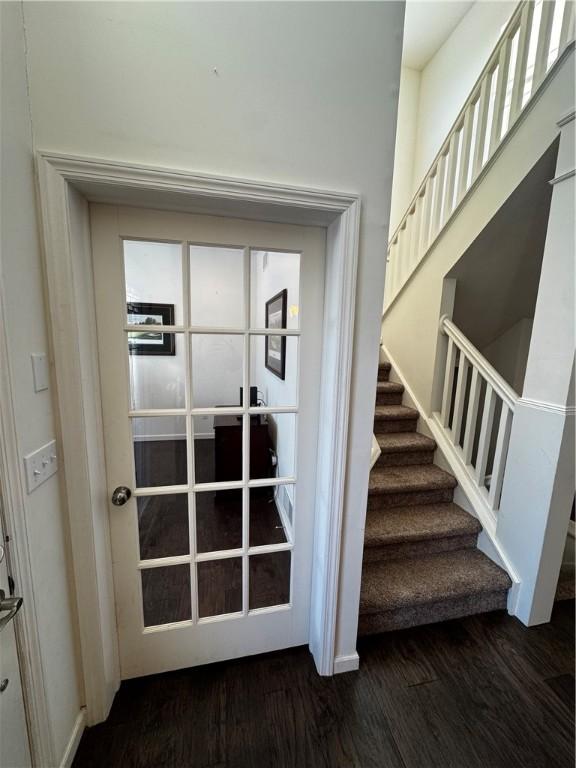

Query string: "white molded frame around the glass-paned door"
[[37, 151, 360, 724]]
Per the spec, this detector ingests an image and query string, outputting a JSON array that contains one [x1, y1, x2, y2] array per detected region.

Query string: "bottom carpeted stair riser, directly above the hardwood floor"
[[358, 590, 507, 635]]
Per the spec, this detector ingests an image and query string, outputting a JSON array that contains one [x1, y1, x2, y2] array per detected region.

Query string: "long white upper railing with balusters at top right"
[[385, 0, 575, 310]]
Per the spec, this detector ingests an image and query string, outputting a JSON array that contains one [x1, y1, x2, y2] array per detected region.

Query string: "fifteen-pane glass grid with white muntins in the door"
[[122, 239, 301, 632]]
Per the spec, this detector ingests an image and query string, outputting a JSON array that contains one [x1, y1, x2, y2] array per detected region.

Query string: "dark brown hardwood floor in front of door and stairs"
[[74, 601, 574, 768]]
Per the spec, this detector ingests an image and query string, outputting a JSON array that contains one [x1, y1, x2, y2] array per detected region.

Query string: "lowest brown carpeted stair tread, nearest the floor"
[[360, 549, 512, 614]]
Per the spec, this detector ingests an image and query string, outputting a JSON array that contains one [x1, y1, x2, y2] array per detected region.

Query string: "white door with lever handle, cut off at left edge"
[[0, 495, 31, 768]]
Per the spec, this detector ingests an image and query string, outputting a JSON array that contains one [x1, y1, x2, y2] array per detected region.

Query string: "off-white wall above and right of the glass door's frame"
[[25, 2, 404, 655]]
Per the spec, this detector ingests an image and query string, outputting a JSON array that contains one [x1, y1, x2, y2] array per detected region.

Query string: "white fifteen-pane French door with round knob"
[[91, 205, 325, 678]]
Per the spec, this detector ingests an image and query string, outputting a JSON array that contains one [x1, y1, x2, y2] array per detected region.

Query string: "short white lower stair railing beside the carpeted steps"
[[433, 316, 519, 515]]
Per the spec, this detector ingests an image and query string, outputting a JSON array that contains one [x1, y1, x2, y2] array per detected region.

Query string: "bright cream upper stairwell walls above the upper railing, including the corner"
[[390, 0, 517, 220]]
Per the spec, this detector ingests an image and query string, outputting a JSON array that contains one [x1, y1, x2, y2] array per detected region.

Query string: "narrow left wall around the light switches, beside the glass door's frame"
[[0, 3, 81, 763]]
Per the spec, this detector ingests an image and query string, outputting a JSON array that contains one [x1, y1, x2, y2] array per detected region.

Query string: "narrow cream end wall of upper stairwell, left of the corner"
[[390, 66, 421, 233]]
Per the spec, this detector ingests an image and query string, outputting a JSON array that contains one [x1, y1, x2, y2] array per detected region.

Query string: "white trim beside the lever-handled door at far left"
[[0, 266, 56, 765]]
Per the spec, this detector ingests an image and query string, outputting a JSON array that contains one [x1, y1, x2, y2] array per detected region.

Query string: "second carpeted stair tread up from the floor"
[[364, 504, 482, 547]]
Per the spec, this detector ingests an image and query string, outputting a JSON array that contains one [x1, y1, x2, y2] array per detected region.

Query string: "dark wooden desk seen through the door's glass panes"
[[214, 416, 274, 483]]
